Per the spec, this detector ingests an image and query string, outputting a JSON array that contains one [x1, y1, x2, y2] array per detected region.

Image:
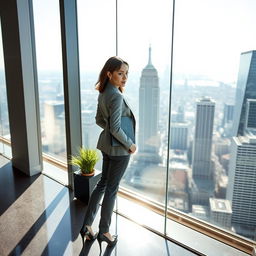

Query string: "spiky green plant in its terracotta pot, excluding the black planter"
[[70, 148, 99, 176]]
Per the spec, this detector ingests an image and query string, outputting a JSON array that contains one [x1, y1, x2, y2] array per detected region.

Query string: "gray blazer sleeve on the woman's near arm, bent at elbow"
[[109, 93, 133, 150]]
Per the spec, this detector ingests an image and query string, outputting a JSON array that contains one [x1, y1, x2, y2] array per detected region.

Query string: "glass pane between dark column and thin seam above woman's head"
[[77, 0, 116, 170]]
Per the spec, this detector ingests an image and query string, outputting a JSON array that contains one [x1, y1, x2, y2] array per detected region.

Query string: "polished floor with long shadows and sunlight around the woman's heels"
[[0, 157, 198, 256]]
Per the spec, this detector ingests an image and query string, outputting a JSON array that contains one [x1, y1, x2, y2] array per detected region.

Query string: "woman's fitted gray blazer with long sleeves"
[[95, 83, 136, 156]]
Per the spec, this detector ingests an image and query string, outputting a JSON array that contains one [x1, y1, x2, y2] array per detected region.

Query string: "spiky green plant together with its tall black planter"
[[69, 148, 101, 204]]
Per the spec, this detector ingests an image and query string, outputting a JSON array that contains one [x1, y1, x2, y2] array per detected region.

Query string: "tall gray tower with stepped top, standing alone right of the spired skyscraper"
[[192, 97, 215, 179]]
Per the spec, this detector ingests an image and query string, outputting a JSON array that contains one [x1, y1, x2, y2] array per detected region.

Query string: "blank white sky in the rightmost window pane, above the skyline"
[[174, 0, 256, 80]]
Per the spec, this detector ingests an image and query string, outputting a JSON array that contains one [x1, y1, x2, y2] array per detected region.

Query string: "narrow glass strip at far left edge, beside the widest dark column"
[[0, 20, 12, 158]]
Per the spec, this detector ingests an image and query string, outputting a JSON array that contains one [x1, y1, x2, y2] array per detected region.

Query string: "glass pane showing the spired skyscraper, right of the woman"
[[118, 0, 172, 232]]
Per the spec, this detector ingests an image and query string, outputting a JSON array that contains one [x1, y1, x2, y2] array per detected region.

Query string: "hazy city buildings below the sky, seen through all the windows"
[[0, 47, 256, 240]]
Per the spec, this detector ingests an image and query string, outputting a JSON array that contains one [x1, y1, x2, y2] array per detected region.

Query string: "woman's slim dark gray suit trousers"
[[83, 152, 130, 233]]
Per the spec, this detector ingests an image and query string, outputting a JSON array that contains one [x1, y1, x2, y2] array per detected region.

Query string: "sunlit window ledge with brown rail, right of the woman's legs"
[[118, 187, 256, 255]]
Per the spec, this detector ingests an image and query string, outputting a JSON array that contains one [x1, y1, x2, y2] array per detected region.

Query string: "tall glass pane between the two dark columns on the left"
[[33, 0, 67, 162]]
